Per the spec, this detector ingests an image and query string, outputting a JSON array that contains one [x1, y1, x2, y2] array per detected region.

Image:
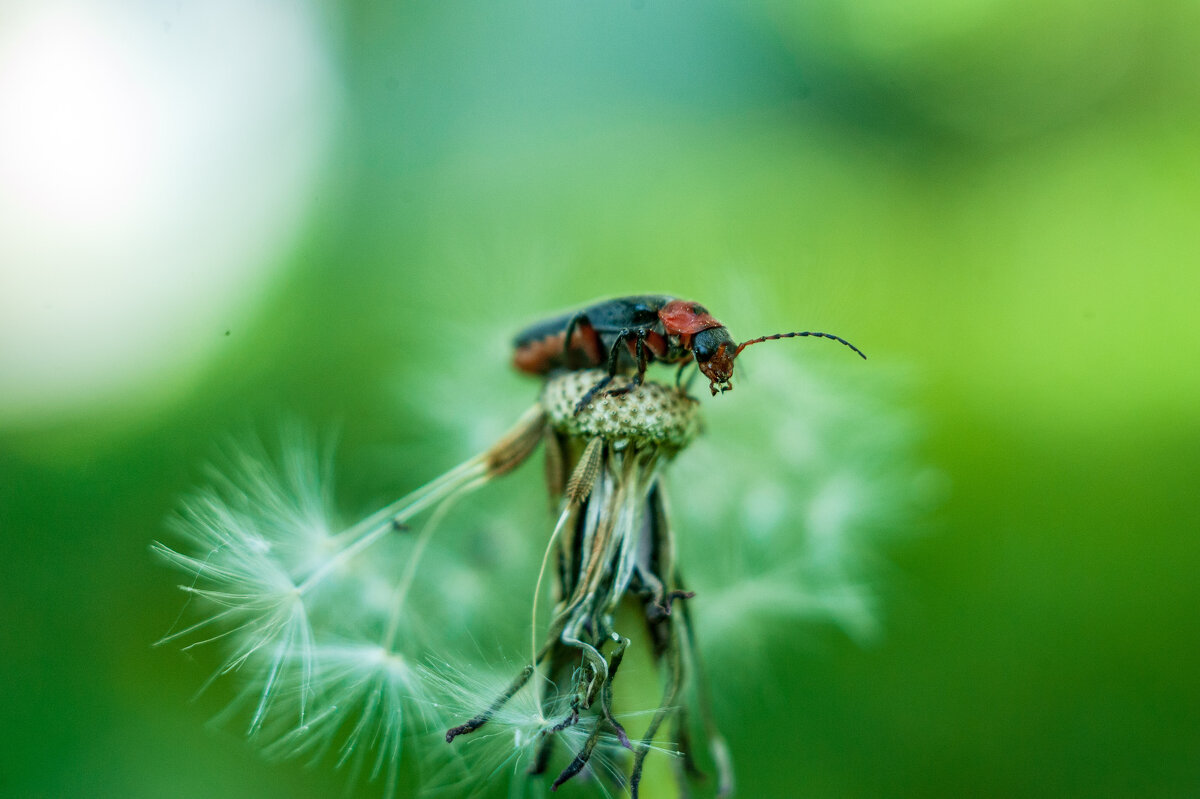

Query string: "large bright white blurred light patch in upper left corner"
[[0, 0, 338, 426]]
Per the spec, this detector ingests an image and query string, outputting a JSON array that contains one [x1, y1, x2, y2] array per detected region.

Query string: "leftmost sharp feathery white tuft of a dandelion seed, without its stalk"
[[152, 429, 332, 733]]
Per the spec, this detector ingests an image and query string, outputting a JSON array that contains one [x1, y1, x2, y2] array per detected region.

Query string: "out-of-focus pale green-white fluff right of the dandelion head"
[[670, 349, 937, 641]]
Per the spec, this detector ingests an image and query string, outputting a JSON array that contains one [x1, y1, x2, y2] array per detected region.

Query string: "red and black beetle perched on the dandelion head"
[[512, 294, 866, 413]]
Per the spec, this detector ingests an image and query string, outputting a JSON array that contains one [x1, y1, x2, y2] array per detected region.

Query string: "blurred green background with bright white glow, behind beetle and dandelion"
[[0, 0, 1200, 797]]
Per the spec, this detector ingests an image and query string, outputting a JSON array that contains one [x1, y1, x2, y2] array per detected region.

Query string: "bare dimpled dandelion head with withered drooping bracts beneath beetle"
[[446, 370, 733, 797]]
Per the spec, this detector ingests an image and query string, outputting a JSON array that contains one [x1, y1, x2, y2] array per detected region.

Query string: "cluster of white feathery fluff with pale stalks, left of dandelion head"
[[152, 433, 482, 794]]
